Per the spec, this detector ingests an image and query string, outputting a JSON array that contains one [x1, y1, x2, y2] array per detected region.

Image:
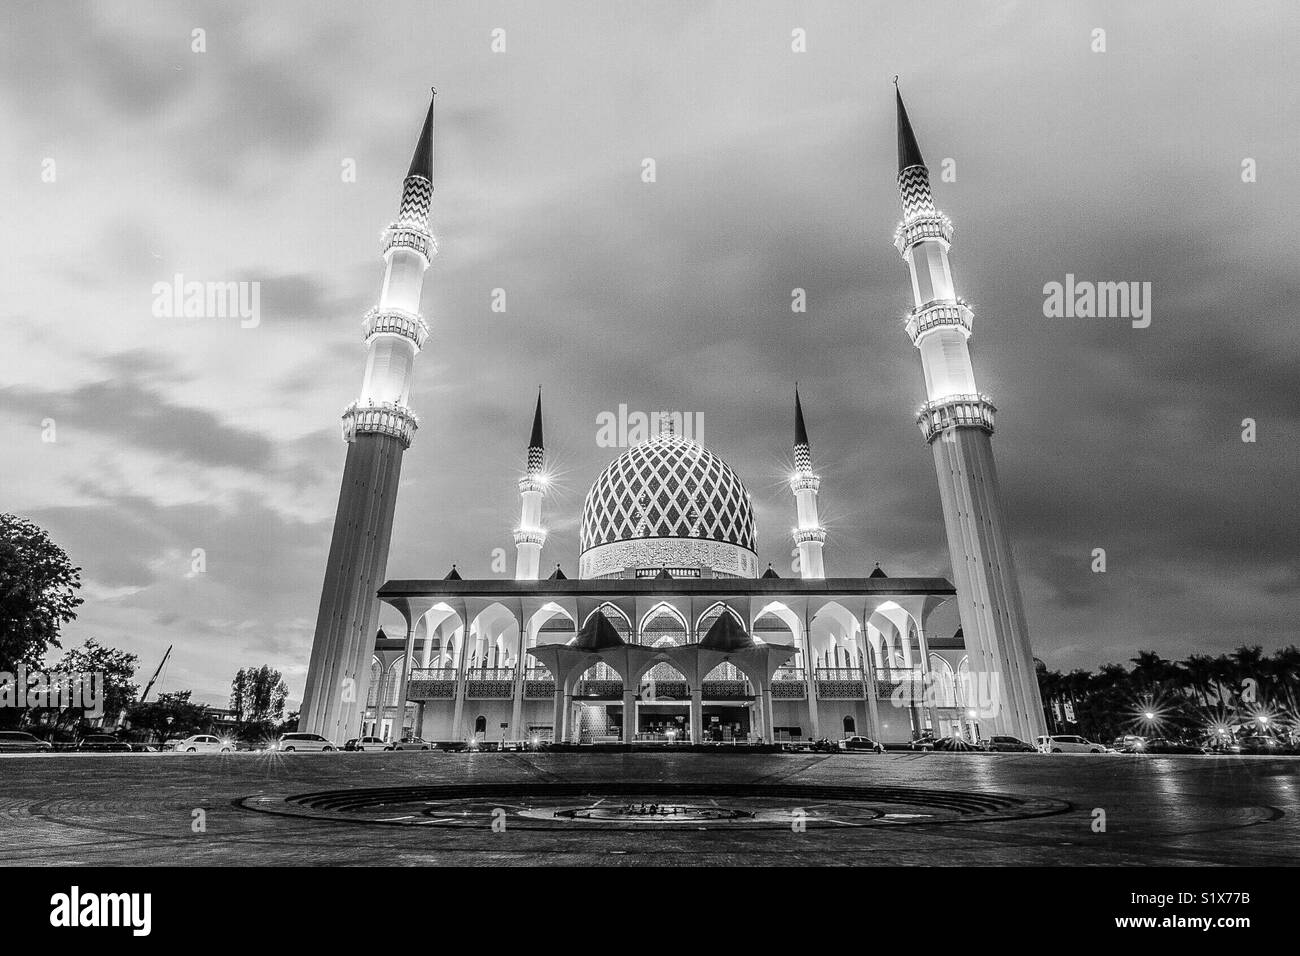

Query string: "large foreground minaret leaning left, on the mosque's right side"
[[894, 83, 1047, 743]]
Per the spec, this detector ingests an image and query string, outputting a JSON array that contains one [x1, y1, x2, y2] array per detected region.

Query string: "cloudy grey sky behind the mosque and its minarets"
[[0, 0, 1300, 704]]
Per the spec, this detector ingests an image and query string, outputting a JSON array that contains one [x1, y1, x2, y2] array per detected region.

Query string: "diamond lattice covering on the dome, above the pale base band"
[[580, 434, 755, 551]]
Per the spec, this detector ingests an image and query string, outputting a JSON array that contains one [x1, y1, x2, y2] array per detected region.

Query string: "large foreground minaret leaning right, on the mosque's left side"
[[299, 89, 437, 744]]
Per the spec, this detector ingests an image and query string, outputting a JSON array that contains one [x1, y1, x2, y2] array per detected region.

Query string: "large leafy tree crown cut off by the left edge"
[[0, 515, 82, 671]]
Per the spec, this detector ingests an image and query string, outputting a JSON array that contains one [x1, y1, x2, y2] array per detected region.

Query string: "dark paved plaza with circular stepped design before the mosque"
[[0, 753, 1300, 866]]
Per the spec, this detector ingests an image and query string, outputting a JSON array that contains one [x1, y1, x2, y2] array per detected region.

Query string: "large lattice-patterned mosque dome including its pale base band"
[[579, 432, 757, 578]]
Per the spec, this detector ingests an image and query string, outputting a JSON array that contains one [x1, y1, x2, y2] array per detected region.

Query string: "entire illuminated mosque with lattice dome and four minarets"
[[299, 89, 1045, 745]]
